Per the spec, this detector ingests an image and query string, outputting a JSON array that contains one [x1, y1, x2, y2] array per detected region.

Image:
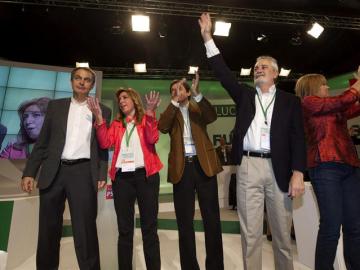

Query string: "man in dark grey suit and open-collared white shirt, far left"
[[21, 67, 111, 270]]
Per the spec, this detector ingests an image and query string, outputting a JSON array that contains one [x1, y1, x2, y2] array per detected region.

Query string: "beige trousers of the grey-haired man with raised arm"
[[236, 156, 294, 270]]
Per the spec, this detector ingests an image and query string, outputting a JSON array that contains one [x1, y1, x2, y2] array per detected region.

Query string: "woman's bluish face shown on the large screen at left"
[[23, 105, 44, 140]]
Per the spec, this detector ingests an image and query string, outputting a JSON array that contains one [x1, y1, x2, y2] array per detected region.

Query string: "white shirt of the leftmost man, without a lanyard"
[[61, 98, 92, 159]]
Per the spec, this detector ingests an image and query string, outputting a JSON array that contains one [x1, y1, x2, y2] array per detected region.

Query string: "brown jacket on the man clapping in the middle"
[[158, 97, 222, 184]]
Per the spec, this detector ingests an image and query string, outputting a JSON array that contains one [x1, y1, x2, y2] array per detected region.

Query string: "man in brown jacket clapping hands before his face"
[[159, 74, 224, 270]]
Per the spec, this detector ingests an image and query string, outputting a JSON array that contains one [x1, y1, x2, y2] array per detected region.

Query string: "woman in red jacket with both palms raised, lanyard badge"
[[88, 88, 162, 270]]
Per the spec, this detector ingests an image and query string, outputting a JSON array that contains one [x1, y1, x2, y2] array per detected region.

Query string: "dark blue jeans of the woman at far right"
[[309, 162, 360, 270]]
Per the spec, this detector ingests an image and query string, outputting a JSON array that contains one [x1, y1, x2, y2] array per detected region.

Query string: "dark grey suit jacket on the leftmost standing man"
[[23, 98, 111, 189]]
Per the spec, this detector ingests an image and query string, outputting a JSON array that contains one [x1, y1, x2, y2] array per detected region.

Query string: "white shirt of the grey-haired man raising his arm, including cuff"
[[205, 39, 276, 152]]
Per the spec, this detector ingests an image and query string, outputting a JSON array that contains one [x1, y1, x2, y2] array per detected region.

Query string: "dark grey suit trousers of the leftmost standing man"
[[36, 161, 100, 270]]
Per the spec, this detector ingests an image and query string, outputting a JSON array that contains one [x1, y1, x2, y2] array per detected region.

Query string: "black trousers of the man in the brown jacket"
[[174, 159, 224, 270]]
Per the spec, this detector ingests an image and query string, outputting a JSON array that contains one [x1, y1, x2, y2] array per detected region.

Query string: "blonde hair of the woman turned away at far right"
[[295, 73, 326, 98]]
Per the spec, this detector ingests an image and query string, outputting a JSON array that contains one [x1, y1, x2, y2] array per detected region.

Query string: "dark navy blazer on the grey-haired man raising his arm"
[[209, 54, 306, 192]]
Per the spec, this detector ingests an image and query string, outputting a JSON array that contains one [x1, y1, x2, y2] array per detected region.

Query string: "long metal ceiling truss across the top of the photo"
[[0, 0, 360, 30]]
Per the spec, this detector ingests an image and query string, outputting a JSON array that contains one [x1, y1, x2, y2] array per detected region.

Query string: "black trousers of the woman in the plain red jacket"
[[112, 169, 161, 270]]
